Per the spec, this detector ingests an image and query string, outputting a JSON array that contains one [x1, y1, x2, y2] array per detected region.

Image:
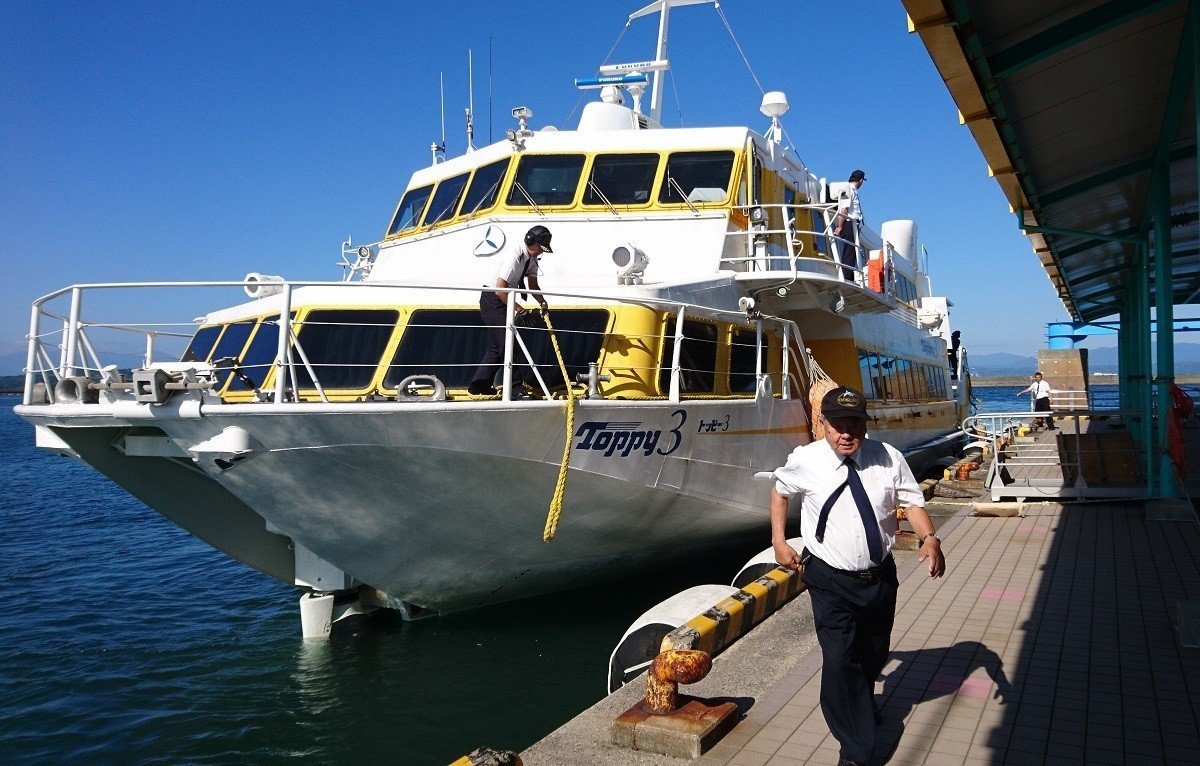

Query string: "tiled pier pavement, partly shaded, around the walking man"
[[695, 503, 1200, 766]]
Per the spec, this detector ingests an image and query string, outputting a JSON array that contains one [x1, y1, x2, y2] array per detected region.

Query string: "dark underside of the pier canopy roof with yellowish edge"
[[904, 0, 1200, 321]]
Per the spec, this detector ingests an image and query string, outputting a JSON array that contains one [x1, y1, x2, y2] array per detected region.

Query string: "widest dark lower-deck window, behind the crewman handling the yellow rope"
[[384, 309, 608, 388]]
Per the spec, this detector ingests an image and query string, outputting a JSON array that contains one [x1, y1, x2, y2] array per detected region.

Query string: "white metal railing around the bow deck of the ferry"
[[23, 281, 804, 405]]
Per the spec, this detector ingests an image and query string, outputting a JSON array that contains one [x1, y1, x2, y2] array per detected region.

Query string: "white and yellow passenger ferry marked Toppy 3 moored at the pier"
[[17, 0, 967, 635]]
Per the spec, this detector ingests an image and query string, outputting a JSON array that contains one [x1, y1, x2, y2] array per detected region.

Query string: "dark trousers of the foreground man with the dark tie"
[[803, 555, 899, 764]]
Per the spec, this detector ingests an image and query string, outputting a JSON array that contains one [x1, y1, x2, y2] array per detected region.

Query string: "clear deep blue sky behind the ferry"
[[0, 0, 1089, 373]]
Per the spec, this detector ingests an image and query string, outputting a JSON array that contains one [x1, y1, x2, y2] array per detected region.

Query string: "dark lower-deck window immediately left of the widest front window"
[[295, 309, 400, 390]]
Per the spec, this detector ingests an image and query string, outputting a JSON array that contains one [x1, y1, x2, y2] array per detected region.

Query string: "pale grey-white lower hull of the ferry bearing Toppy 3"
[[19, 397, 960, 614]]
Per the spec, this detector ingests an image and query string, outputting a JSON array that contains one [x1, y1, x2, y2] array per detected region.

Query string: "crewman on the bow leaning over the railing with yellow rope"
[[467, 226, 554, 399]]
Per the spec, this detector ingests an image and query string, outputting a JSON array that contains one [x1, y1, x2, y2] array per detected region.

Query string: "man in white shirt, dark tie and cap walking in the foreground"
[[770, 387, 946, 765]]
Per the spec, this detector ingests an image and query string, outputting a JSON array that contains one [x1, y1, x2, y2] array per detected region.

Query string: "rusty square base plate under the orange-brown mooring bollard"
[[612, 695, 738, 758]]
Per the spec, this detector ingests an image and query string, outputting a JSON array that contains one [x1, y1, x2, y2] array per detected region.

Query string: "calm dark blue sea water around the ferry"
[[0, 387, 1108, 764]]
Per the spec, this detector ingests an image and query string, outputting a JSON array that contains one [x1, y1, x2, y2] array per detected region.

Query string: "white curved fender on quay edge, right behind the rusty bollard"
[[608, 585, 738, 694]]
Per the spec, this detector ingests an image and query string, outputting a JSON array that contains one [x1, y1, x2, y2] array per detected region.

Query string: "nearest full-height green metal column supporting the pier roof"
[[1150, 164, 1178, 497]]
